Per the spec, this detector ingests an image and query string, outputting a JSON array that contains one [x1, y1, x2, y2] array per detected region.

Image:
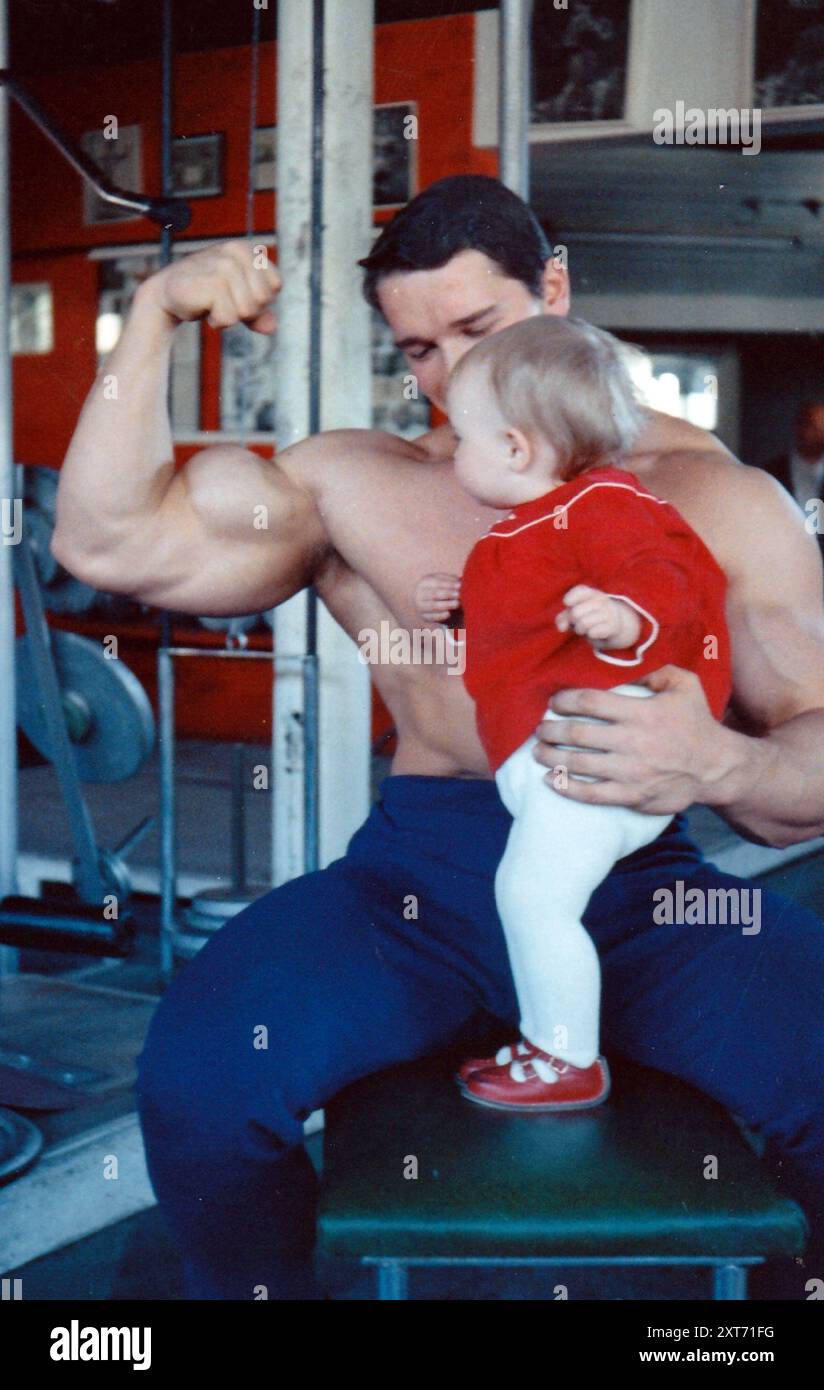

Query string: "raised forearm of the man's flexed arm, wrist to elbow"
[[53, 285, 176, 573]]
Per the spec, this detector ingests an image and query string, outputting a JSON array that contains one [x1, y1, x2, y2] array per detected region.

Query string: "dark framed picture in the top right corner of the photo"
[[753, 0, 824, 117]]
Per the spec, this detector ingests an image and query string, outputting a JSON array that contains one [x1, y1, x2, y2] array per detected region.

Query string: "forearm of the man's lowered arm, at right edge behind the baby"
[[702, 710, 824, 848]]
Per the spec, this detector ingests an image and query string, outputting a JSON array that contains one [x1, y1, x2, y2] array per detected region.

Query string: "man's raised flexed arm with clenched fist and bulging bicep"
[[51, 242, 329, 616]]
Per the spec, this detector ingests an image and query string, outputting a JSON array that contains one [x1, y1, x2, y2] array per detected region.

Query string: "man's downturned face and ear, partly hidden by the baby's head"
[[378, 250, 568, 410]]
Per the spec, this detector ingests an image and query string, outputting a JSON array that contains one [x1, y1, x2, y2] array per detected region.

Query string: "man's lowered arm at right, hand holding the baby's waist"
[[535, 468, 824, 847]]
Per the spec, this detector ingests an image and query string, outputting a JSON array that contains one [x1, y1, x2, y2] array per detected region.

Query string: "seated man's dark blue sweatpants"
[[136, 776, 824, 1300]]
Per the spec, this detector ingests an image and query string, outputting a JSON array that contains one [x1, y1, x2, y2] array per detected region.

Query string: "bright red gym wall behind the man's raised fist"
[[11, 14, 496, 738]]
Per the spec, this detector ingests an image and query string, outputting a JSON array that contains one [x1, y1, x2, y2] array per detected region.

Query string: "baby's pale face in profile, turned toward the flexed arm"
[[446, 368, 521, 507]]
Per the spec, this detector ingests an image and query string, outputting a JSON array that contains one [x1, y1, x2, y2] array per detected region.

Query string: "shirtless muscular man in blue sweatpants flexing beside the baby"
[[53, 175, 824, 1298]]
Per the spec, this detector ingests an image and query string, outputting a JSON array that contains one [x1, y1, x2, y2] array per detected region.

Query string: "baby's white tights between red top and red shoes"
[[495, 685, 673, 1066]]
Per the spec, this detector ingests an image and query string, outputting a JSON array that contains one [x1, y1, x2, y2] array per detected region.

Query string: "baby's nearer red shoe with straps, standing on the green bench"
[[463, 1048, 610, 1112]]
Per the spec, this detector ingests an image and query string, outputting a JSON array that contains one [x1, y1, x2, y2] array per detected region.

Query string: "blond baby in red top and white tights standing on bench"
[[417, 314, 731, 1111]]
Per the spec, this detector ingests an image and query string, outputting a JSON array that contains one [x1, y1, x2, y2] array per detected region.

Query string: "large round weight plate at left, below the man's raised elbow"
[[15, 630, 154, 783]]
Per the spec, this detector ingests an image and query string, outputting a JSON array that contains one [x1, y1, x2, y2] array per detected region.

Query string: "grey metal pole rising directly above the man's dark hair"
[[499, 0, 532, 202]]
